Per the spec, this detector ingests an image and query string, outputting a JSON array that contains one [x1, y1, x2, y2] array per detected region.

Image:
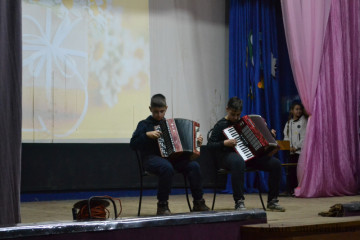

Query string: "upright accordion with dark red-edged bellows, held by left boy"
[[154, 118, 200, 160]]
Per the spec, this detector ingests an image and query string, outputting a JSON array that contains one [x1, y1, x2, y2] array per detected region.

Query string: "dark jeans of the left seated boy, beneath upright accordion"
[[145, 155, 203, 201]]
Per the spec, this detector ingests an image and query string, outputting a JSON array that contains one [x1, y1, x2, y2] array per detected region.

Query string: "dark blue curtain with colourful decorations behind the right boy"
[[227, 0, 297, 193]]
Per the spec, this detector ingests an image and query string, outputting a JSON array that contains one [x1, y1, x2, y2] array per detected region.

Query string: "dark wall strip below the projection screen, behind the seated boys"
[[21, 143, 222, 193]]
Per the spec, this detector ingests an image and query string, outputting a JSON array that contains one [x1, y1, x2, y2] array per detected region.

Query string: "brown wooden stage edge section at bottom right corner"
[[240, 220, 360, 240]]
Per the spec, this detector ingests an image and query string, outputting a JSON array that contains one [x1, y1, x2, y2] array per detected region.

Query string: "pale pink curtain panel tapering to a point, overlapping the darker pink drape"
[[281, 0, 331, 114]]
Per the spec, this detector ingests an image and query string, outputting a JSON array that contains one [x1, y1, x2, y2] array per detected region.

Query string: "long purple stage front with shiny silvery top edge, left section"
[[0, 209, 267, 240]]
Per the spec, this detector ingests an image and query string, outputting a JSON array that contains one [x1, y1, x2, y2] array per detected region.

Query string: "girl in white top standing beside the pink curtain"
[[284, 102, 307, 194]]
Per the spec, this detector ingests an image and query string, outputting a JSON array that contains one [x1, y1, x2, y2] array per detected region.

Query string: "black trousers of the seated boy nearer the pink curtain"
[[222, 152, 281, 202]]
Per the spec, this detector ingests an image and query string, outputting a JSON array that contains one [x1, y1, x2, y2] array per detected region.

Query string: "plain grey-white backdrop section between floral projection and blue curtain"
[[150, 0, 228, 136]]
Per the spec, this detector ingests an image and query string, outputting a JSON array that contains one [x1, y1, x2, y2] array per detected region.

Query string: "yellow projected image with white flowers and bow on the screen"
[[22, 0, 150, 142]]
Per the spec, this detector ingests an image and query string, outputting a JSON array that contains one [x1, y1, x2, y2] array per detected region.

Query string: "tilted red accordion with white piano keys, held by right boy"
[[223, 115, 278, 161]]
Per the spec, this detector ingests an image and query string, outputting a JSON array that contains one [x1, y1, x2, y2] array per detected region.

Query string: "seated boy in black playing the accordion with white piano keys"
[[207, 97, 285, 212]]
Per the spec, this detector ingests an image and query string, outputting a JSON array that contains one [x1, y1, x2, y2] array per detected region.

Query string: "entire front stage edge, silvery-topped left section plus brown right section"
[[0, 212, 360, 240]]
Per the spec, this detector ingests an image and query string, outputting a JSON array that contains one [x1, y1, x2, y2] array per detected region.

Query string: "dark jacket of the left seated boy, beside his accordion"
[[130, 116, 160, 159]]
